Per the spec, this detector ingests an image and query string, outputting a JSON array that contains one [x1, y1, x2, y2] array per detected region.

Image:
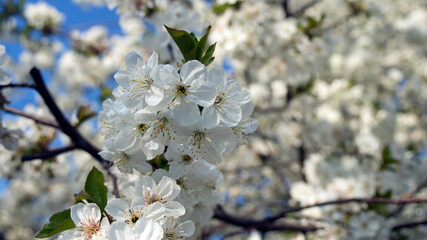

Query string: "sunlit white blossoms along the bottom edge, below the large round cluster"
[[58, 176, 195, 240]]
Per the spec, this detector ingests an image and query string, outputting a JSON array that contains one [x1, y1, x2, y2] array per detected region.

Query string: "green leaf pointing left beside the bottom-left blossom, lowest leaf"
[[36, 209, 76, 238]]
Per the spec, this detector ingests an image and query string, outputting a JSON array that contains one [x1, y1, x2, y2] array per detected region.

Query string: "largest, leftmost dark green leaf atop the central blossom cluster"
[[165, 25, 197, 61]]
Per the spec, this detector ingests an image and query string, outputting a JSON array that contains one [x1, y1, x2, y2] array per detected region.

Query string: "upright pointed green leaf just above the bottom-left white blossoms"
[[85, 167, 108, 212]]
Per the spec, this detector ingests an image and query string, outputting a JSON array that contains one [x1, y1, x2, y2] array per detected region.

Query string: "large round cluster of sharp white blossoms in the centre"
[[98, 51, 258, 237]]
